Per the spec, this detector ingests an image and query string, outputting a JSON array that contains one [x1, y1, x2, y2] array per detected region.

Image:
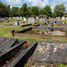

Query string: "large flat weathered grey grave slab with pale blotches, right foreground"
[[31, 42, 67, 67]]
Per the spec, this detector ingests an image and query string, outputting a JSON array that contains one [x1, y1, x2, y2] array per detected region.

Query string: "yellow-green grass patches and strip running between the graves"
[[0, 19, 67, 67]]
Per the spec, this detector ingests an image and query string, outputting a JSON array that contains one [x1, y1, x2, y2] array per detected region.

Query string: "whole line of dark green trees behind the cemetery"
[[0, 2, 67, 17]]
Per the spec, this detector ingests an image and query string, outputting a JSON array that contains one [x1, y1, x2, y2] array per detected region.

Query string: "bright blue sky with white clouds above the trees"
[[0, 0, 67, 9]]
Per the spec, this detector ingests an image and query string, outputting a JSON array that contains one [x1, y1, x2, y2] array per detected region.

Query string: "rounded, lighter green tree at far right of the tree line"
[[54, 4, 65, 17]]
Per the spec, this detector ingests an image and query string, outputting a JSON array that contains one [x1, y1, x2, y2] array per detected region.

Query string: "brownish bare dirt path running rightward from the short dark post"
[[15, 33, 67, 41]]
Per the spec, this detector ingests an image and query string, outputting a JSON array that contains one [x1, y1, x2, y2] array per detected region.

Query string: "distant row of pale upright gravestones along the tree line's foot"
[[0, 17, 67, 22]]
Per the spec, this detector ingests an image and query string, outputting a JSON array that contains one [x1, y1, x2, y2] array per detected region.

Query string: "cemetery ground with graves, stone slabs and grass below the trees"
[[0, 18, 67, 67]]
